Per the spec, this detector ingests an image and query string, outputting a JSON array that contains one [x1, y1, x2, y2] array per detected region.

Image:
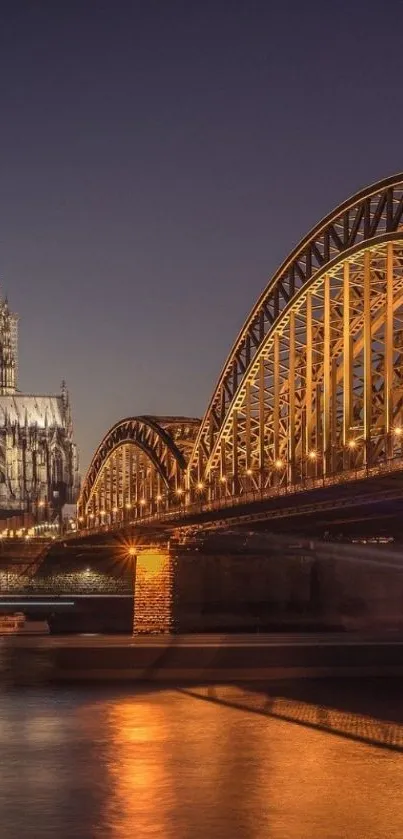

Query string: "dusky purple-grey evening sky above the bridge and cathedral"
[[0, 0, 403, 471]]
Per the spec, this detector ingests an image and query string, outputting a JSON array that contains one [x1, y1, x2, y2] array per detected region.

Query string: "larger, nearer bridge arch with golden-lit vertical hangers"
[[187, 174, 403, 501]]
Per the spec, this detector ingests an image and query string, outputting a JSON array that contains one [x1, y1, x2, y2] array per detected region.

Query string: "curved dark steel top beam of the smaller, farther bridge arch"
[[78, 415, 186, 511]]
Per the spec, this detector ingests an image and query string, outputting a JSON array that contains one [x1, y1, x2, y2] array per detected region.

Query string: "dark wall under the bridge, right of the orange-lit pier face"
[[173, 546, 403, 631]]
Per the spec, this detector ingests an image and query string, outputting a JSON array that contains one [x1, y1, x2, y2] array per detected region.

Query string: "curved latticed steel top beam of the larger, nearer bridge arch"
[[189, 173, 403, 480]]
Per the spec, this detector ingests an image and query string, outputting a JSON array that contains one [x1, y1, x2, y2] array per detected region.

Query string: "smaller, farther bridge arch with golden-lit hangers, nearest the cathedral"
[[78, 416, 200, 527]]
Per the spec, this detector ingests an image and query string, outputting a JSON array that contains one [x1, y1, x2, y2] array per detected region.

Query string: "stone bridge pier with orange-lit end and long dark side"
[[129, 539, 330, 635]]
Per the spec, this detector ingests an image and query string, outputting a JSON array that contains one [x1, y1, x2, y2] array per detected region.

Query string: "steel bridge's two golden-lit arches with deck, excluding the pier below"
[[78, 174, 403, 535]]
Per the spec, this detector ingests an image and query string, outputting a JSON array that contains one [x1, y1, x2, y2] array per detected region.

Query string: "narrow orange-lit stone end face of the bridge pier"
[[133, 547, 174, 635]]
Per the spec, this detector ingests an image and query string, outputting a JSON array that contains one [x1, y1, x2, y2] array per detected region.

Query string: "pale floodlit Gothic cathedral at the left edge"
[[0, 299, 79, 520]]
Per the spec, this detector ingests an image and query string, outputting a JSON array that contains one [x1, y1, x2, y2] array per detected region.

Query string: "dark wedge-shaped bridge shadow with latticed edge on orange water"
[[178, 678, 403, 753]]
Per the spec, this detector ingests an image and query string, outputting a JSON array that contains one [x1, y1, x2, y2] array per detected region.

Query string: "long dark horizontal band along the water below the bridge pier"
[[0, 633, 403, 685]]
